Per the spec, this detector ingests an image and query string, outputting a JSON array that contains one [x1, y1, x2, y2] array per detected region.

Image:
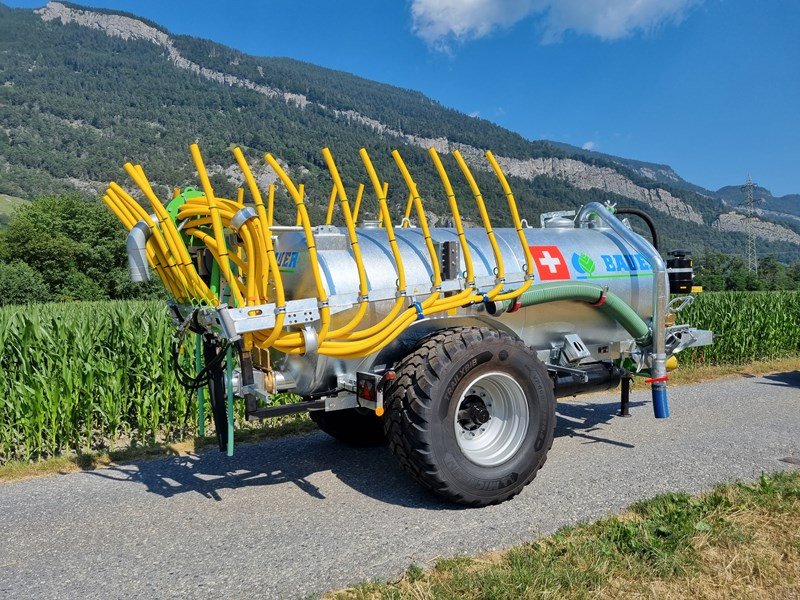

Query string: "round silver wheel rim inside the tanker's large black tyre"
[[453, 371, 529, 467]]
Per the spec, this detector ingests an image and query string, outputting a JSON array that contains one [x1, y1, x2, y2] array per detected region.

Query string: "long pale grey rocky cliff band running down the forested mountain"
[[37, 2, 788, 242]]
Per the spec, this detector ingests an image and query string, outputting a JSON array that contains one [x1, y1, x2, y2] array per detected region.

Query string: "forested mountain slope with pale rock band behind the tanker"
[[0, 2, 800, 260]]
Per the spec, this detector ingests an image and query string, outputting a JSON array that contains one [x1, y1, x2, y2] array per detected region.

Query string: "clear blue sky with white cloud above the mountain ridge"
[[4, 0, 800, 195]]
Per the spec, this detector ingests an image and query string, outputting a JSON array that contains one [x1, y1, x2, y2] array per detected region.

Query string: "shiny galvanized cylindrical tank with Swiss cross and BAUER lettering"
[[276, 221, 654, 394]]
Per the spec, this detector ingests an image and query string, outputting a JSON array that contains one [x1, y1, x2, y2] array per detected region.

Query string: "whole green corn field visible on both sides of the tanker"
[[0, 292, 800, 464]]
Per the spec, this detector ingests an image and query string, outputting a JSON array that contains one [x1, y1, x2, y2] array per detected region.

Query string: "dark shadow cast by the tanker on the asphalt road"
[[87, 402, 642, 510]]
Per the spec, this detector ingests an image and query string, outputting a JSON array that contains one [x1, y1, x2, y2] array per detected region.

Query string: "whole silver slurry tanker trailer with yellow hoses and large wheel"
[[104, 145, 712, 506]]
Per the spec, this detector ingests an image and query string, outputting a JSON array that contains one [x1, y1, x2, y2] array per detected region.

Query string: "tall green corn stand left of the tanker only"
[[0, 301, 194, 462]]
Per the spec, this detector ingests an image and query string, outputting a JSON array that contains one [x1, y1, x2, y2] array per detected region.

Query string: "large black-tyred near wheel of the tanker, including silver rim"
[[384, 327, 556, 506]]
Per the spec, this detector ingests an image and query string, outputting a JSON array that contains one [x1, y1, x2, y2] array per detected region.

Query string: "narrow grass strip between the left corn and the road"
[[0, 415, 317, 483]]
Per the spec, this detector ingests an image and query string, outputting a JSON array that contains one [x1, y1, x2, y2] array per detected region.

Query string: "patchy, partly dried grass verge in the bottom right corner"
[[328, 472, 800, 600]]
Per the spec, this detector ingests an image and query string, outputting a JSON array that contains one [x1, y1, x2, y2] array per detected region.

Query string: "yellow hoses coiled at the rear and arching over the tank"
[[103, 144, 534, 359]]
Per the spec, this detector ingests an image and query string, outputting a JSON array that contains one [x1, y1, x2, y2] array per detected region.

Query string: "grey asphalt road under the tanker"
[[0, 372, 800, 600]]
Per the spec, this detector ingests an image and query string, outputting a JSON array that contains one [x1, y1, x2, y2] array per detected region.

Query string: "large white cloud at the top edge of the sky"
[[411, 0, 703, 50]]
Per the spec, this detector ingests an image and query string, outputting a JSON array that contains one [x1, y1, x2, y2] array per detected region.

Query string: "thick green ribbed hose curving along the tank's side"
[[487, 281, 650, 344]]
